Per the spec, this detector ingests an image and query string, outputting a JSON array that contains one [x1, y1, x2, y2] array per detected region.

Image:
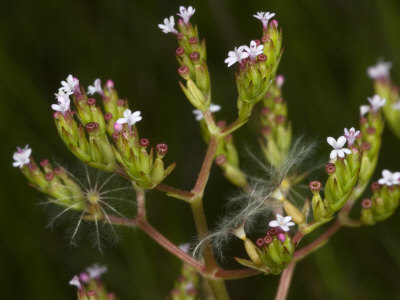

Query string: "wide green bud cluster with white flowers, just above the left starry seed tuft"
[[52, 75, 174, 188]]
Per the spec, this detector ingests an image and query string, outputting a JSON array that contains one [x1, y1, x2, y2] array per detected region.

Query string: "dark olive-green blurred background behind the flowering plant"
[[0, 0, 400, 300]]
